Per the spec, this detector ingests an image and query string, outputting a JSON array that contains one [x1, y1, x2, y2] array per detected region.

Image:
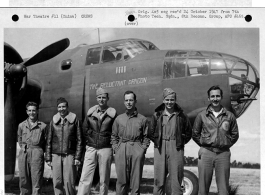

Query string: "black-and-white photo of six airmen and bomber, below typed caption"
[[2, 8, 264, 195]]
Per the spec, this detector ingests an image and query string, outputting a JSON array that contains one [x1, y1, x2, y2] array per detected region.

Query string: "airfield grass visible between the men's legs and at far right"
[[5, 164, 260, 195]]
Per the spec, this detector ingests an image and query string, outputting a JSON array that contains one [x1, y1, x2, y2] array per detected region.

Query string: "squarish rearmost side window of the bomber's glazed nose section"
[[163, 58, 186, 79]]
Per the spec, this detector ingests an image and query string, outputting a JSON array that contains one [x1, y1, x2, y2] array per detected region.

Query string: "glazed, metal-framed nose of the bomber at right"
[[163, 50, 260, 117]]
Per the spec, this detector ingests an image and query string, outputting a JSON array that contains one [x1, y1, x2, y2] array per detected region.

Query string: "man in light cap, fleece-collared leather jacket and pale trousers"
[[78, 88, 116, 195]]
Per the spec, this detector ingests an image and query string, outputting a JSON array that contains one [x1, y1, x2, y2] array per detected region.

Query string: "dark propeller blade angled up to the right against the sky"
[[24, 38, 70, 66]]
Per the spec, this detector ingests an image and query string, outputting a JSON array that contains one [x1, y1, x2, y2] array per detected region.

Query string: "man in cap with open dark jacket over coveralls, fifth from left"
[[149, 88, 192, 195]]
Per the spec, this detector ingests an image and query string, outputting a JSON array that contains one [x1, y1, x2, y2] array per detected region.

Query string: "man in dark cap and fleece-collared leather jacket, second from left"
[[46, 98, 82, 195]]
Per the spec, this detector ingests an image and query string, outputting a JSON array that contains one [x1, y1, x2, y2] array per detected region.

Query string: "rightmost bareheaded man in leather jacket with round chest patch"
[[192, 86, 239, 195]]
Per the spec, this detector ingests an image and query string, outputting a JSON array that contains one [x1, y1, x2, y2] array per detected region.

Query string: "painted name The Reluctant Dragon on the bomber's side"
[[89, 77, 147, 89]]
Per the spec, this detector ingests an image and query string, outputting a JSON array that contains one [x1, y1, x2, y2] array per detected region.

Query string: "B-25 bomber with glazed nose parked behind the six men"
[[4, 38, 260, 194]]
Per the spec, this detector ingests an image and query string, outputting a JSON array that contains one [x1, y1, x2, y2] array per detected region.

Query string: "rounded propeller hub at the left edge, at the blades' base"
[[5, 62, 27, 79]]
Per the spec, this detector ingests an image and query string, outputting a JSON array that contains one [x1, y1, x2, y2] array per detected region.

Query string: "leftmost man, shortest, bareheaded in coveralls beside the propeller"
[[18, 102, 46, 195]]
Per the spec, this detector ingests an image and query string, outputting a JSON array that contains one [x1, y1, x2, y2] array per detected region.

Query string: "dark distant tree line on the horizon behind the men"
[[144, 156, 260, 169]]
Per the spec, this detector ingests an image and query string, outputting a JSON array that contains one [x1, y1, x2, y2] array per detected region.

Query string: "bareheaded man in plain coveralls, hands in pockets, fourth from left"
[[111, 91, 150, 195]]
